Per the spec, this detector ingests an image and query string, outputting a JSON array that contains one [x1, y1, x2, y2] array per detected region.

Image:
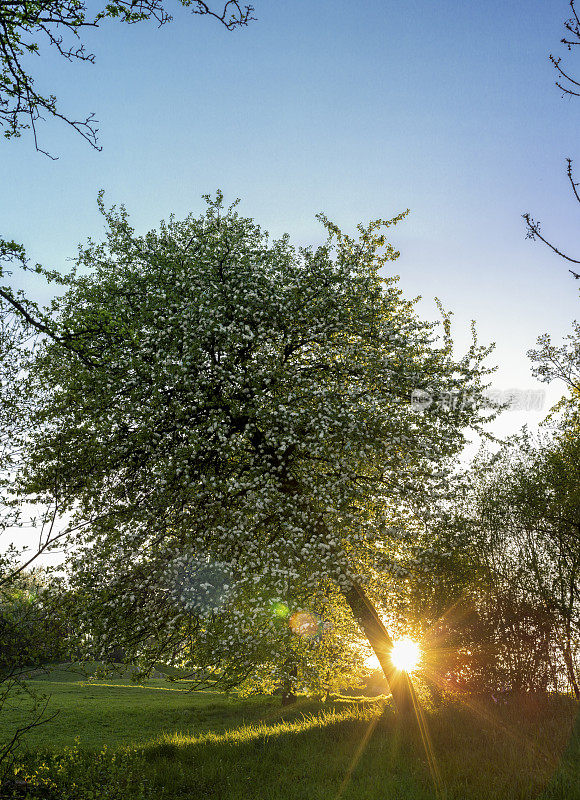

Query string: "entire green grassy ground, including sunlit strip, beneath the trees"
[[0, 672, 580, 800]]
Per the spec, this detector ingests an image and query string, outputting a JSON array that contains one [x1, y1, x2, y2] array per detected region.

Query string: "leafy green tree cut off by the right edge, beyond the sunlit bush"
[[472, 432, 580, 699]]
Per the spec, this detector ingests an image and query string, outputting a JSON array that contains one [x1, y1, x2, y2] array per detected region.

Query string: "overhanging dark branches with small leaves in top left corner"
[[0, 0, 254, 158]]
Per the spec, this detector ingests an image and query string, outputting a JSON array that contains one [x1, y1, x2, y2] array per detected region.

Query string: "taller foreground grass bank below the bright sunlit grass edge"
[[139, 698, 580, 800]]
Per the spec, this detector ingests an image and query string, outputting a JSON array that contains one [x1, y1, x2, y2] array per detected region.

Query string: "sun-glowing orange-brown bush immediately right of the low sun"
[[392, 496, 556, 698]]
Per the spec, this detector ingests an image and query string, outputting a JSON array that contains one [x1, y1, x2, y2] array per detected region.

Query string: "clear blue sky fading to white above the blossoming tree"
[[0, 0, 580, 444]]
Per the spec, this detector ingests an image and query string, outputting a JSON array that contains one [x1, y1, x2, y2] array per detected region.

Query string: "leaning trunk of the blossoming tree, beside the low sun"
[[343, 583, 413, 713]]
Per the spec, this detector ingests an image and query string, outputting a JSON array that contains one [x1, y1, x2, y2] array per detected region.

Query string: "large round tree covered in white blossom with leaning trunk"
[[21, 193, 489, 702]]
